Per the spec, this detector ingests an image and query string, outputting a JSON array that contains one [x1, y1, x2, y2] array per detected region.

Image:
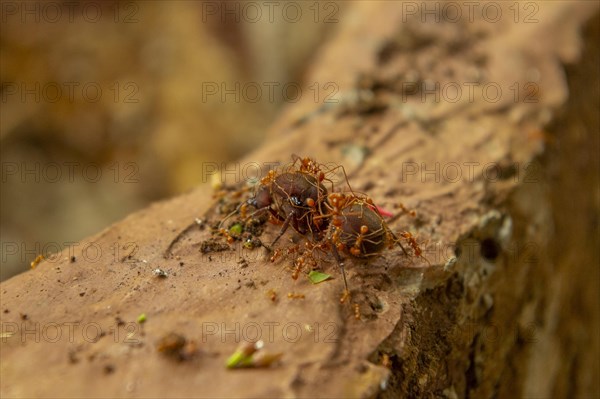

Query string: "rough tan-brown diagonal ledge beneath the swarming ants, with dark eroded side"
[[1, 2, 600, 398]]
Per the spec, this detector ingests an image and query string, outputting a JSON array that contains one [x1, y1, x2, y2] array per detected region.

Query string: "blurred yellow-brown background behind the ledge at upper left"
[[0, 1, 346, 280]]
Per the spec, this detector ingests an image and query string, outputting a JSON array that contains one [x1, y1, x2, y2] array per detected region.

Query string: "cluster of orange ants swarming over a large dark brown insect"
[[216, 155, 426, 303]]
